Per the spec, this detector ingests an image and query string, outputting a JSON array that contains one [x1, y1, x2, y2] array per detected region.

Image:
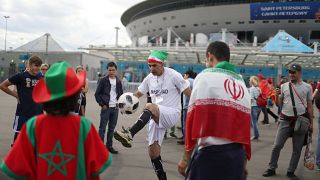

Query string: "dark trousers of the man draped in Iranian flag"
[[186, 143, 245, 180]]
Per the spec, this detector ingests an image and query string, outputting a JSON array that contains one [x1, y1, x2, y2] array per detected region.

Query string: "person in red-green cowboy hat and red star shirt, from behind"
[[0, 61, 112, 180]]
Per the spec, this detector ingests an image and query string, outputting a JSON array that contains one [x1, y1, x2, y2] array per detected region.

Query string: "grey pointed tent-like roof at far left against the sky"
[[13, 33, 65, 52]]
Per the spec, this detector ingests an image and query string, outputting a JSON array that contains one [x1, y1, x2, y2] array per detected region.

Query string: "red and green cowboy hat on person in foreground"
[[32, 61, 86, 103]]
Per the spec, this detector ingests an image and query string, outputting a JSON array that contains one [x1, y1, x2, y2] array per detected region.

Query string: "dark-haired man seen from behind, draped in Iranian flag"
[[178, 41, 251, 180]]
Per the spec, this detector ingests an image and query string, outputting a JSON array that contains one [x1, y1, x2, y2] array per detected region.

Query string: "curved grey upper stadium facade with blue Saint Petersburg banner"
[[121, 0, 320, 44]]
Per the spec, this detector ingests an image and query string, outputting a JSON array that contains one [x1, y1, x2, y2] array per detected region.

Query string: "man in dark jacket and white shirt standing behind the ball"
[[94, 62, 123, 154]]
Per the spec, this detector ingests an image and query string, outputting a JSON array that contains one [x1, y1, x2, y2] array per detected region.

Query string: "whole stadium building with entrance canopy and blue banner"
[[84, 0, 320, 82]]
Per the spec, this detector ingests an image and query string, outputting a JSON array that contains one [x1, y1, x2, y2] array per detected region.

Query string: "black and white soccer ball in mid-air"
[[118, 92, 139, 114]]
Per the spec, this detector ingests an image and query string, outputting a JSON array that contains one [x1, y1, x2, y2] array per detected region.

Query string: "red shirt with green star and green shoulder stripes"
[[1, 115, 112, 180]]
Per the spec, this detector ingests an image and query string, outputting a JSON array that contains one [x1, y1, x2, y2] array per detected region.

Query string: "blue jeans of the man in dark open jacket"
[[99, 107, 119, 148]]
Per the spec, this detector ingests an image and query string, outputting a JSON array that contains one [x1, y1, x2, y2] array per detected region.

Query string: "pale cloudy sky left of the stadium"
[[0, 0, 143, 51]]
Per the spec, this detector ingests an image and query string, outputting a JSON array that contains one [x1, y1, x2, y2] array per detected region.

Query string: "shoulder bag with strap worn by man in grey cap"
[[289, 83, 310, 134]]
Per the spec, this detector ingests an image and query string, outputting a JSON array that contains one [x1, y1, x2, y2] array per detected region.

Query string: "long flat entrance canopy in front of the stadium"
[[86, 47, 320, 68]]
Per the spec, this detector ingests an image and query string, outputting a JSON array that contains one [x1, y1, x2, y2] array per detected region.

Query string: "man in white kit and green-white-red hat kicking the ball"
[[114, 51, 191, 180]]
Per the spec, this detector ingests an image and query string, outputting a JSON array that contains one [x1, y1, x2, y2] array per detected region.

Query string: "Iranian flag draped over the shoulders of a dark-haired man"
[[186, 67, 251, 159]]
